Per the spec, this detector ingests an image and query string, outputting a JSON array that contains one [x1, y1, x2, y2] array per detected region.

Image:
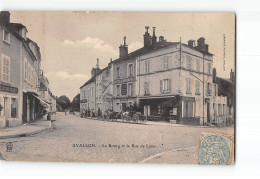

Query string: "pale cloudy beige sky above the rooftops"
[[10, 11, 235, 100]]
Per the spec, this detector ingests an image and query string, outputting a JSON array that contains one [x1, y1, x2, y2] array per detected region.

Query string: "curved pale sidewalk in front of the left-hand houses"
[[0, 117, 50, 139]]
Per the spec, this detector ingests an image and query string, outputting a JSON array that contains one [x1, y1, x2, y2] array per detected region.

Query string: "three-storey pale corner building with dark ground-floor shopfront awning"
[[137, 29, 213, 125]]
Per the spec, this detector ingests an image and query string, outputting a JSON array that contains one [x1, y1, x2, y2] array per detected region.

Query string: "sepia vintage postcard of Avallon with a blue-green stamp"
[[0, 11, 236, 165]]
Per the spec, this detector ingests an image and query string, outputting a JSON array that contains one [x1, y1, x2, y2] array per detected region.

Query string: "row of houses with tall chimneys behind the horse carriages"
[[80, 26, 234, 125]]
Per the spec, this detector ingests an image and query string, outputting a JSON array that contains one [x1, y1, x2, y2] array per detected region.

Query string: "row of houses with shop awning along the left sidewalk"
[[0, 11, 56, 128]]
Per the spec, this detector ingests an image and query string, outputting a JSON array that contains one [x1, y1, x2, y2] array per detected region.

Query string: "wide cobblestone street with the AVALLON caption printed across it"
[[0, 113, 234, 163]]
